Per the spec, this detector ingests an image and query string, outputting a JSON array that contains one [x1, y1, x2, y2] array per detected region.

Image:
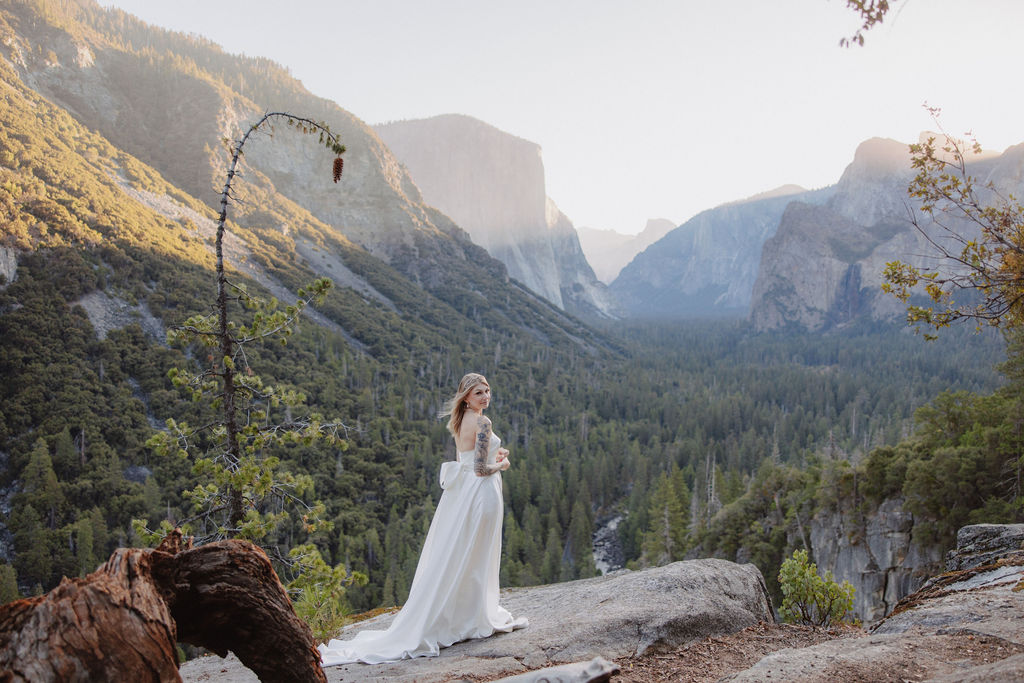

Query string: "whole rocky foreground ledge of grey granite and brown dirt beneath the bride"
[[181, 524, 1024, 683]]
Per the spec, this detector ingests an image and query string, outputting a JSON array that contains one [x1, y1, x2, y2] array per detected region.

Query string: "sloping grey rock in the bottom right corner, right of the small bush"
[[724, 524, 1024, 683]]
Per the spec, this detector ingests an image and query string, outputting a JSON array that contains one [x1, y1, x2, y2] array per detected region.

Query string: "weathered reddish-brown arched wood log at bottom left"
[[0, 532, 327, 683]]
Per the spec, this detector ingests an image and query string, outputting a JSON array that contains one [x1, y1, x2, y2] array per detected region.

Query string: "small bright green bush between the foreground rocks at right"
[[778, 550, 854, 626]]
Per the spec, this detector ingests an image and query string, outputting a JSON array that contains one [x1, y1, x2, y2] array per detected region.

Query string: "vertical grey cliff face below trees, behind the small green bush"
[[810, 499, 942, 625]]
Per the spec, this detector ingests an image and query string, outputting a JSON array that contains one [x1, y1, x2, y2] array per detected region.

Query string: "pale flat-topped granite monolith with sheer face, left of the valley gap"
[[375, 114, 610, 316]]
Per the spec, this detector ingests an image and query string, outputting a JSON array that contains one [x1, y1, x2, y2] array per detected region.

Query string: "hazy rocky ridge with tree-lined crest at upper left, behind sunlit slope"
[[0, 0, 593, 328]]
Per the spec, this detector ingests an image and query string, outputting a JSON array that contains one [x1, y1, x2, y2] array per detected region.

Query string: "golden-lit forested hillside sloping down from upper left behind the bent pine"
[[0, 3, 614, 604]]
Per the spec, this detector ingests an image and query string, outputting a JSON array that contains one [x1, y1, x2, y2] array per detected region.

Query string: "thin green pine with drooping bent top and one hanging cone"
[[143, 112, 345, 541]]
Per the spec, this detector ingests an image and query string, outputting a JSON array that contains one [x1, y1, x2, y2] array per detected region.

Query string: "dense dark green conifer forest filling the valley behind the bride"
[[0, 233, 1007, 611]]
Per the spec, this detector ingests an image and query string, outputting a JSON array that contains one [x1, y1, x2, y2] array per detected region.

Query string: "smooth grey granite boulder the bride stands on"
[[181, 559, 773, 682]]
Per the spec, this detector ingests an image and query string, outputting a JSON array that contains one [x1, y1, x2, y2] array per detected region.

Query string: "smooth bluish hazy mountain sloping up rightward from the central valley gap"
[[608, 185, 828, 317]]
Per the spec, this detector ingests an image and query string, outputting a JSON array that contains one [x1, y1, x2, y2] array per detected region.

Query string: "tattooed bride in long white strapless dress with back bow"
[[319, 373, 527, 667]]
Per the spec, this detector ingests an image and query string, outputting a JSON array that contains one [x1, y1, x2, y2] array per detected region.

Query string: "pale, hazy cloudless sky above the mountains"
[[99, 0, 1024, 233]]
